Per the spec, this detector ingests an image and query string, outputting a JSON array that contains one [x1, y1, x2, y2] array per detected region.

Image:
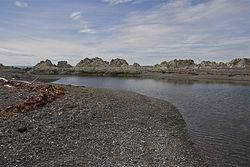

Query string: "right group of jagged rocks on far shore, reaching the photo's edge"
[[147, 58, 250, 76]]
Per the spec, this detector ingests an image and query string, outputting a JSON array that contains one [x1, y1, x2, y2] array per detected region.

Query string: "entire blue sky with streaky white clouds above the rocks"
[[0, 0, 250, 65]]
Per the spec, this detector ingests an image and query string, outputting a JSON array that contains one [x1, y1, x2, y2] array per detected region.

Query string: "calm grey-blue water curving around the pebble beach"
[[53, 76, 250, 167]]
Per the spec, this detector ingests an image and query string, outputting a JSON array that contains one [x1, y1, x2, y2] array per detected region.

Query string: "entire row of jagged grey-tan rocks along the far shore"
[[30, 57, 250, 75]]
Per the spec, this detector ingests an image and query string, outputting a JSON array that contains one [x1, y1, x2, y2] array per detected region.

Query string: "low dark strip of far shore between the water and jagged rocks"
[[0, 64, 250, 85]]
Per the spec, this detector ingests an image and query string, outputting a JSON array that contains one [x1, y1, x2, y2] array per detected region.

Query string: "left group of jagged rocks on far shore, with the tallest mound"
[[30, 57, 143, 75]]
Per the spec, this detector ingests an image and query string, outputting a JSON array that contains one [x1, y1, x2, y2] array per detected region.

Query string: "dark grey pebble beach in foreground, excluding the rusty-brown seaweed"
[[0, 72, 206, 167]]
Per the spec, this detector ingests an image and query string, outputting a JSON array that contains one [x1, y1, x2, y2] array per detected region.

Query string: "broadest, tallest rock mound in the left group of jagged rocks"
[[76, 57, 109, 67]]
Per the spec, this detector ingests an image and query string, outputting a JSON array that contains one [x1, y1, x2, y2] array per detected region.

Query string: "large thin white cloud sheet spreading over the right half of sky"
[[97, 0, 250, 63]]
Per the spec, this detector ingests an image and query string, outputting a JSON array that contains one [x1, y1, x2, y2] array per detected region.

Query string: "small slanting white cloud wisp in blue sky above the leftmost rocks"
[[70, 11, 96, 34]]
